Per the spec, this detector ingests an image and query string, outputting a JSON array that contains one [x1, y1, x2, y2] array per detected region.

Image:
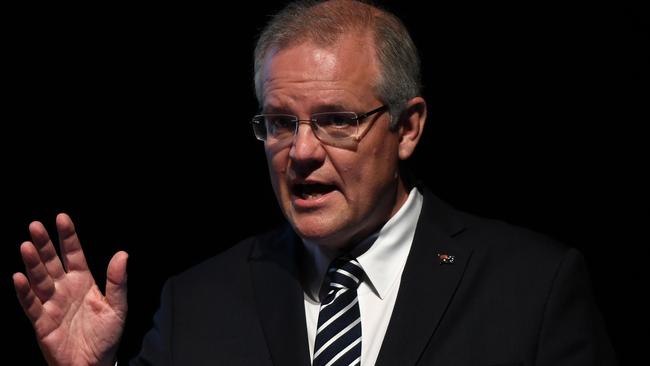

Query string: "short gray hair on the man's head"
[[254, 0, 421, 129]]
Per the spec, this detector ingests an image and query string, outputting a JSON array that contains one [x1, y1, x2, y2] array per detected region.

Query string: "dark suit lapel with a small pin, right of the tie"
[[376, 191, 472, 366]]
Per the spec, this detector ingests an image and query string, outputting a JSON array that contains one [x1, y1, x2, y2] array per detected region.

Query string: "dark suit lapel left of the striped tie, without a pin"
[[250, 229, 310, 365]]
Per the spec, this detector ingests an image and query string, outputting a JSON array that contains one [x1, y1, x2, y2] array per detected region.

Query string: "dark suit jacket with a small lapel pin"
[[132, 192, 616, 366]]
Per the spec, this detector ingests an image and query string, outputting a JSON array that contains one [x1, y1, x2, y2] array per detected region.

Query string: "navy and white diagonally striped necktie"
[[313, 257, 364, 366]]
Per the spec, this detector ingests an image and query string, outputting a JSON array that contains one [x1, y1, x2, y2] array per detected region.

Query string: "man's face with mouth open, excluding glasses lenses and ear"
[[262, 37, 406, 249]]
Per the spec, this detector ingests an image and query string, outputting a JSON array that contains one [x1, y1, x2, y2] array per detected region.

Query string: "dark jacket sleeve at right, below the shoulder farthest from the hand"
[[536, 249, 617, 366]]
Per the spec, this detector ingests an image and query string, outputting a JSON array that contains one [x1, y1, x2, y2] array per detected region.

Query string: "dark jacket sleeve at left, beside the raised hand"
[[129, 279, 174, 366]]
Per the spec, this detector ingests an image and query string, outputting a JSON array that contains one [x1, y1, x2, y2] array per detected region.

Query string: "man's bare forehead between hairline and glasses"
[[261, 36, 378, 110]]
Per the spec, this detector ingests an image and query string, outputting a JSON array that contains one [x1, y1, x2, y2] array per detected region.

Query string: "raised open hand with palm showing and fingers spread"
[[13, 214, 128, 365]]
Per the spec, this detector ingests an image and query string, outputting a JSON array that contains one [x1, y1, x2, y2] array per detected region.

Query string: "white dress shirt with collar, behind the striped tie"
[[301, 188, 423, 366]]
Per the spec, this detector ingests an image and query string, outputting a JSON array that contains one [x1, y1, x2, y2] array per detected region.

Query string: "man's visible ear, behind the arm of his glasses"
[[398, 97, 427, 160]]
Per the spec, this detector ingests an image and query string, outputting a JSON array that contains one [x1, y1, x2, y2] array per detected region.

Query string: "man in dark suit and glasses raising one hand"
[[14, 0, 615, 365]]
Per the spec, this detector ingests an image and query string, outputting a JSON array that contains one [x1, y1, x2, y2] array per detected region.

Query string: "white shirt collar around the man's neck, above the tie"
[[303, 188, 424, 300]]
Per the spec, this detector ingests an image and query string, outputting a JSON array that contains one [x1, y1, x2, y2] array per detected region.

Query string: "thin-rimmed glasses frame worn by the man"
[[251, 104, 388, 146]]
